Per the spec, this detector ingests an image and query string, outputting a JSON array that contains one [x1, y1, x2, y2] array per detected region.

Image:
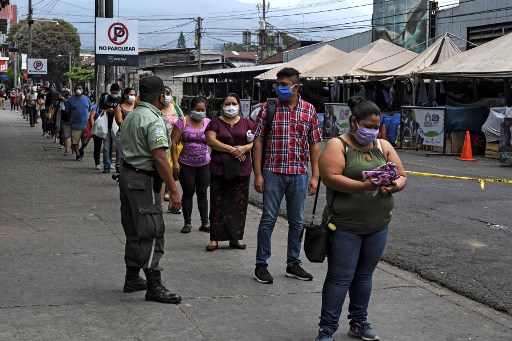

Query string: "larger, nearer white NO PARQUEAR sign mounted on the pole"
[[96, 18, 139, 66]]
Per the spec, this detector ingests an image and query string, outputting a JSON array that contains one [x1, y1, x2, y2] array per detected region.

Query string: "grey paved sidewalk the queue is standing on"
[[0, 111, 512, 341]]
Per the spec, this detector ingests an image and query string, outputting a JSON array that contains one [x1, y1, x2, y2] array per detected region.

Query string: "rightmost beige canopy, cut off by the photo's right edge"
[[419, 33, 512, 78]]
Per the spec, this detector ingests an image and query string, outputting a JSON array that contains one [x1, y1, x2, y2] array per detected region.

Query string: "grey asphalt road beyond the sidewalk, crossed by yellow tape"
[[251, 143, 512, 315]]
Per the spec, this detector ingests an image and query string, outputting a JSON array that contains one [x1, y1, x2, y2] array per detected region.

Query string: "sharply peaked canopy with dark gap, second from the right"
[[357, 33, 461, 77]]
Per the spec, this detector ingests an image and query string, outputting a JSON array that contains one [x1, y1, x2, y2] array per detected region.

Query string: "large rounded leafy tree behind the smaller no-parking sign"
[[7, 19, 80, 85]]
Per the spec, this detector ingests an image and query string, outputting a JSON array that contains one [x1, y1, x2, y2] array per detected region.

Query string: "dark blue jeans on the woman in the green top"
[[318, 227, 388, 334]]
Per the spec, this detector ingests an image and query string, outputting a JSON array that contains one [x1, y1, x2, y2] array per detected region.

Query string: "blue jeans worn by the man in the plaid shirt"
[[256, 171, 308, 265]]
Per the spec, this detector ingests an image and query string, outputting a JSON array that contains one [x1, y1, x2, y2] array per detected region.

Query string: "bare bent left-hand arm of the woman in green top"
[[318, 138, 377, 193]]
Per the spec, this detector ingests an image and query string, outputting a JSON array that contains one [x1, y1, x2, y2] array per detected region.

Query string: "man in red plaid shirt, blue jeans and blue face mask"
[[253, 68, 321, 283]]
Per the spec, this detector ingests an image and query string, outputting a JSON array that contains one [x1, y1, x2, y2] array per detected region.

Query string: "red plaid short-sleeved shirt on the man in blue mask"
[[254, 97, 322, 174]]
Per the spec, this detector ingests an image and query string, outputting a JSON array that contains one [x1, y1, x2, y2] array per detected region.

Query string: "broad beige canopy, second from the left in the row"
[[301, 39, 418, 78]]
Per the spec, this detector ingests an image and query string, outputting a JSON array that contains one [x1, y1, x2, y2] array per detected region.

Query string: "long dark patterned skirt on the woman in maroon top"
[[210, 173, 250, 241]]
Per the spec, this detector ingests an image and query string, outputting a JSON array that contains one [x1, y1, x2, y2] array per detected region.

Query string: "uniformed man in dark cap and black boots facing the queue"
[[119, 76, 181, 304]]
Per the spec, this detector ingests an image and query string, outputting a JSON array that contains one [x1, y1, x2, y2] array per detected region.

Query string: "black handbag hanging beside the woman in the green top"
[[304, 179, 337, 263]]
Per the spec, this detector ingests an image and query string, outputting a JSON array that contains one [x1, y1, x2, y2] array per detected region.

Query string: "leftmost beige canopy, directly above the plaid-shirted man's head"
[[255, 45, 347, 80]]
